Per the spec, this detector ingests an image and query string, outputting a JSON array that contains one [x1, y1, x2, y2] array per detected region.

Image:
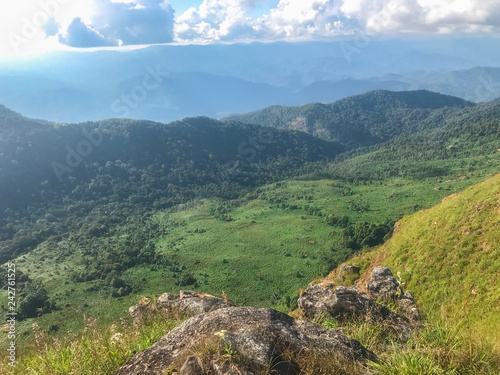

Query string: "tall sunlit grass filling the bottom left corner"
[[0, 316, 180, 375]]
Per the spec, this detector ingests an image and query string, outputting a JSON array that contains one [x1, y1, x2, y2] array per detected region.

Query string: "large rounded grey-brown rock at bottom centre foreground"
[[116, 307, 377, 375]]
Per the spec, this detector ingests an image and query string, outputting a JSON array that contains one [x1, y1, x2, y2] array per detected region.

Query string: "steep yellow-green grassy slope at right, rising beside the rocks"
[[342, 175, 500, 350]]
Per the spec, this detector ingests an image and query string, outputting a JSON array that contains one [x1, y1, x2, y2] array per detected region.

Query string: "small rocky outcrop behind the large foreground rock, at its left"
[[129, 290, 231, 325]]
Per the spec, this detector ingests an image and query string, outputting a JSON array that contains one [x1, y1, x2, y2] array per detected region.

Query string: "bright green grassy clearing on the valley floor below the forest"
[[0, 176, 492, 346]]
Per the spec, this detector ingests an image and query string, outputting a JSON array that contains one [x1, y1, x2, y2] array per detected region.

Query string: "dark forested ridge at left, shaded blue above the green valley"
[[0, 107, 343, 261]]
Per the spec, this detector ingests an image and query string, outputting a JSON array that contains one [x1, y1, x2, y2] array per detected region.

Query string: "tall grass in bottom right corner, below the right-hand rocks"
[[315, 306, 500, 375]]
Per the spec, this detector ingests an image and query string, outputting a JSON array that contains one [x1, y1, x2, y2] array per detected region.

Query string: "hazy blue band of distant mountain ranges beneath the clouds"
[[0, 38, 500, 122]]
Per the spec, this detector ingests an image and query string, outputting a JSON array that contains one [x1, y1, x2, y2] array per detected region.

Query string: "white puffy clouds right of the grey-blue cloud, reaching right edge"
[[175, 0, 500, 42]]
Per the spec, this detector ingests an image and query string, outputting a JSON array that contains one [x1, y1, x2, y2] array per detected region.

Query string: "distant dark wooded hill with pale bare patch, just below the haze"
[[227, 90, 474, 148]]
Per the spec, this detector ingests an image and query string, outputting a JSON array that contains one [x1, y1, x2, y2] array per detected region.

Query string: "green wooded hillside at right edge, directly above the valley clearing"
[[330, 103, 500, 181]]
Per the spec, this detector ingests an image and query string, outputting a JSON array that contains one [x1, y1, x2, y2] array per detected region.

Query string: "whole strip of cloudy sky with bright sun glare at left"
[[0, 0, 500, 57]]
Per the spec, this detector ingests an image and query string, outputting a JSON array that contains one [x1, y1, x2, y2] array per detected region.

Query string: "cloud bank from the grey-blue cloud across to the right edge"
[[53, 0, 500, 47]]
